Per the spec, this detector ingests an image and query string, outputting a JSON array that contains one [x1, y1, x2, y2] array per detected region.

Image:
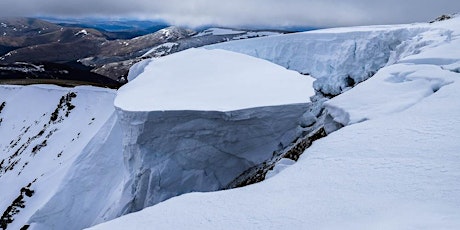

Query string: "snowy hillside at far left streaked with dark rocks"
[[0, 85, 115, 229]]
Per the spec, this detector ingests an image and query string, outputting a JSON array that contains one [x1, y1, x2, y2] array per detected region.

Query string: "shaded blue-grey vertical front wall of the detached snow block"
[[119, 104, 306, 213]]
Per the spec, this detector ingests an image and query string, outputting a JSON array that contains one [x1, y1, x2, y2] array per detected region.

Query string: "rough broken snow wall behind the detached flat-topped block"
[[206, 24, 444, 96]]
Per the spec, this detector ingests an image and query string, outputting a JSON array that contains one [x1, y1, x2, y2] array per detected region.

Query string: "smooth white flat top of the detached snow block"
[[115, 49, 314, 111]]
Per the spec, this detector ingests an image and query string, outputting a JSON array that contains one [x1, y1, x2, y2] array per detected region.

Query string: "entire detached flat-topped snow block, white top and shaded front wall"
[[115, 49, 313, 214]]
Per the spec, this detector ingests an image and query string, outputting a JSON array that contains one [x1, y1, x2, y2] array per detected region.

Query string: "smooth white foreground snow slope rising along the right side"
[[92, 18, 460, 230]]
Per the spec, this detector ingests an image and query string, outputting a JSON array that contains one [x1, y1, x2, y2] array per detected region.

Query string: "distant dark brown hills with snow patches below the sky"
[[0, 18, 285, 87]]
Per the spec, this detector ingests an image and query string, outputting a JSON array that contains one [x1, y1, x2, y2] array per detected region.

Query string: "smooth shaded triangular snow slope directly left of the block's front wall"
[[27, 113, 126, 229]]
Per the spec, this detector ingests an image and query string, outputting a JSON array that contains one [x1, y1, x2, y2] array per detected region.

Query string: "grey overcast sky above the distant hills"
[[0, 0, 460, 27]]
